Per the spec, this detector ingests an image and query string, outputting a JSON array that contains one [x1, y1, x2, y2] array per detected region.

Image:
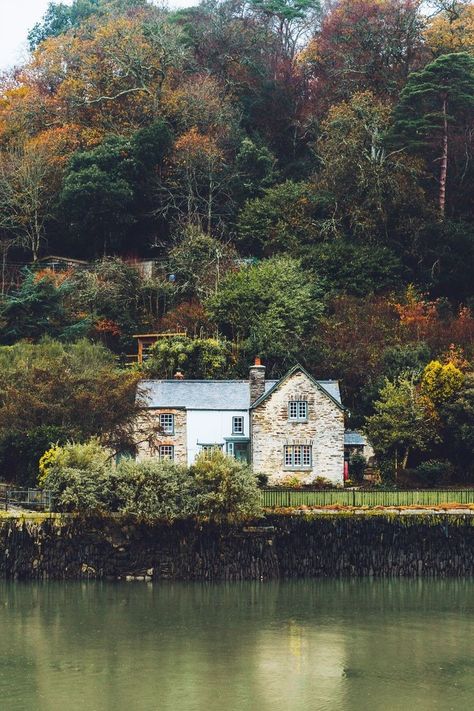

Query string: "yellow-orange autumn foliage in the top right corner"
[[424, 4, 474, 55]]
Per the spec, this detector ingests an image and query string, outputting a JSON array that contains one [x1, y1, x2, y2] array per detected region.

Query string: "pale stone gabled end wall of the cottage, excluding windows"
[[251, 371, 344, 485]]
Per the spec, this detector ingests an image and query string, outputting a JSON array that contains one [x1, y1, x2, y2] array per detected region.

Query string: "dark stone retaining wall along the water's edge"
[[0, 512, 474, 581]]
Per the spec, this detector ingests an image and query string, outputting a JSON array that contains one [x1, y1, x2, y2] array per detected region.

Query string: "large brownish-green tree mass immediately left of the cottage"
[[0, 340, 138, 479]]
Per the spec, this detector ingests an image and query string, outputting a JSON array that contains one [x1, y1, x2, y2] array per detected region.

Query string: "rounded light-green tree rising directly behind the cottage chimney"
[[207, 257, 323, 367]]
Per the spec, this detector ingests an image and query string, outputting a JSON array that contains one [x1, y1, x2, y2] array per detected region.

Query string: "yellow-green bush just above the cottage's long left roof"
[[142, 336, 232, 379]]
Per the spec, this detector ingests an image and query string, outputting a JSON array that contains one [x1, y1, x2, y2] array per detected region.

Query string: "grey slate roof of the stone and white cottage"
[[138, 380, 341, 410]]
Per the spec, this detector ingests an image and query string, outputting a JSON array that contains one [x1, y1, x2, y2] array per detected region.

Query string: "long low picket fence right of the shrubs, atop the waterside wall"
[[262, 489, 474, 508]]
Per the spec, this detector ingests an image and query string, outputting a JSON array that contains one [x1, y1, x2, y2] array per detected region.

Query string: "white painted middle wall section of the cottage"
[[186, 410, 249, 464]]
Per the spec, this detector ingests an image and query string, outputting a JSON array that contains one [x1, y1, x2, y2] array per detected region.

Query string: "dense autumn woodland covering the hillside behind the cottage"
[[0, 0, 474, 481]]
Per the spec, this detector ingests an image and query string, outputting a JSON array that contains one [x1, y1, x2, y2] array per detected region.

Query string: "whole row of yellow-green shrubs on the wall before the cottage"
[[40, 439, 261, 521]]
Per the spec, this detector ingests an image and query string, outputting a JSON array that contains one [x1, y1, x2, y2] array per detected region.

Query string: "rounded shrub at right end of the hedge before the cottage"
[[190, 449, 261, 521]]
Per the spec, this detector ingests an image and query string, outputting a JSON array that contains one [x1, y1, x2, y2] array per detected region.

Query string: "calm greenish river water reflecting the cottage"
[[0, 581, 474, 711]]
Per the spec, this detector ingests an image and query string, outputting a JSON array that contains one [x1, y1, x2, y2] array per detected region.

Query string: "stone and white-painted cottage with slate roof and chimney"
[[137, 359, 345, 486]]
